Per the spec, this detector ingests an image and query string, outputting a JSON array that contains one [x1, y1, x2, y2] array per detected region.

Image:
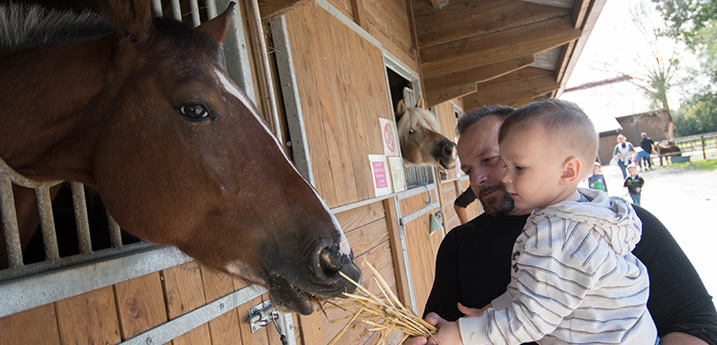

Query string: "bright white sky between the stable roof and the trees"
[[558, 0, 690, 132]]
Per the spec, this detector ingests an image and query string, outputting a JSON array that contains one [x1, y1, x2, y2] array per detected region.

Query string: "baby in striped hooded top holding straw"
[[422, 100, 659, 345]]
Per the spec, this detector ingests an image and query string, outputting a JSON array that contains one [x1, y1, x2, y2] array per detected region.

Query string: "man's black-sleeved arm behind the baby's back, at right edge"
[[633, 206, 717, 345]]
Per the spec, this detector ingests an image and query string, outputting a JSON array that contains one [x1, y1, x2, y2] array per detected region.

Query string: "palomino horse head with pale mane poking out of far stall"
[[396, 100, 456, 169]]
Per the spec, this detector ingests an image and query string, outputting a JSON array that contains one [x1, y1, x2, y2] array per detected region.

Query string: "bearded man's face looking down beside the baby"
[[456, 115, 526, 215]]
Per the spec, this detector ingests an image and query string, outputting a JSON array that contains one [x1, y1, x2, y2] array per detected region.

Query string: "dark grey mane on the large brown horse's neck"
[[0, 2, 112, 51]]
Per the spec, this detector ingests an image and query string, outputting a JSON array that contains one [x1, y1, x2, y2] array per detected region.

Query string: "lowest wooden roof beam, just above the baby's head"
[[463, 76, 560, 109]]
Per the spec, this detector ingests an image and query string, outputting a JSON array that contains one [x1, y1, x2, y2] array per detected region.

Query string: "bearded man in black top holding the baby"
[[404, 106, 717, 345]]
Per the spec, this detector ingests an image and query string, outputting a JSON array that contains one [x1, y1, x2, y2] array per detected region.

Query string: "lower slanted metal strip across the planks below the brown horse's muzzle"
[[120, 285, 266, 345]]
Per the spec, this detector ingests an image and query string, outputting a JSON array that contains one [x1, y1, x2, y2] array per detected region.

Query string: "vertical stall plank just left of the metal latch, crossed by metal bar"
[[201, 267, 242, 345]]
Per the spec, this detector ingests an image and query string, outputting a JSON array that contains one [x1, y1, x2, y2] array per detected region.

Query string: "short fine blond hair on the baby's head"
[[498, 99, 599, 179]]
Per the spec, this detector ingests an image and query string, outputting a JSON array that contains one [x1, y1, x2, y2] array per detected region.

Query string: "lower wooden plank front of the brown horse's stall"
[[0, 262, 290, 345]]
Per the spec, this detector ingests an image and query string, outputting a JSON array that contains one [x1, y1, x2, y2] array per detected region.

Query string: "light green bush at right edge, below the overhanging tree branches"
[[674, 92, 717, 137]]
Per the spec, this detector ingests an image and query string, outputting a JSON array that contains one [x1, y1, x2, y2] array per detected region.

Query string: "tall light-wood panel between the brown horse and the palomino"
[[286, 2, 393, 207]]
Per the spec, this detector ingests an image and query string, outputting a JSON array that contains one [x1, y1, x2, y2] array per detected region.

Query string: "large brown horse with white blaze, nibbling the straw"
[[0, 0, 360, 314]]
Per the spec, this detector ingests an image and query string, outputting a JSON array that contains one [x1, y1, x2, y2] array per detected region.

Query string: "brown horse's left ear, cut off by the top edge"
[[104, 0, 152, 42]]
